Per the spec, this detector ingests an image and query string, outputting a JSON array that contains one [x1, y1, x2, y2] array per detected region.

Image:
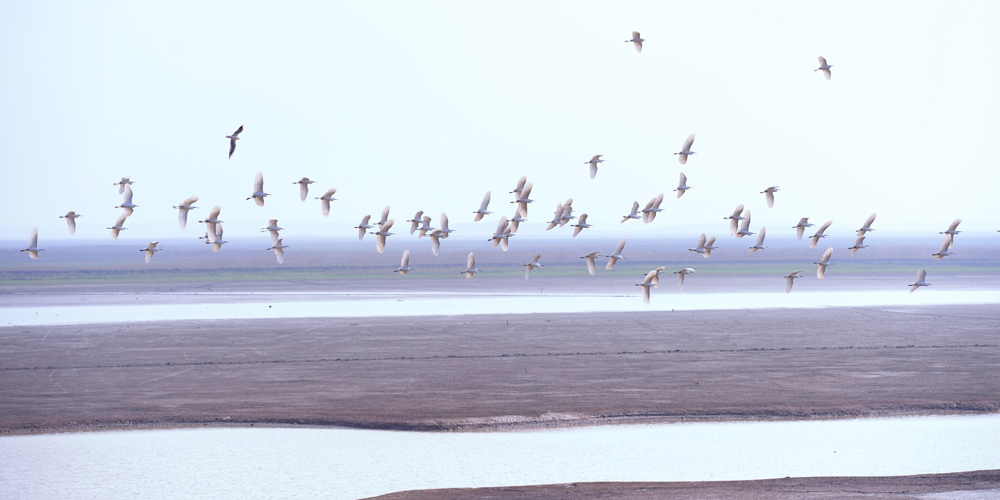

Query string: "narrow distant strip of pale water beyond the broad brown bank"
[[0, 289, 1000, 326]]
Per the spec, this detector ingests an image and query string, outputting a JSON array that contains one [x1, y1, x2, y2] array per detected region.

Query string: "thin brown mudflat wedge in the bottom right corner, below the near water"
[[366, 470, 1000, 500]]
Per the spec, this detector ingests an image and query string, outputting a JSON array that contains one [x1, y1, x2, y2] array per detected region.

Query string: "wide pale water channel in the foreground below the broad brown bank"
[[0, 415, 1000, 499]]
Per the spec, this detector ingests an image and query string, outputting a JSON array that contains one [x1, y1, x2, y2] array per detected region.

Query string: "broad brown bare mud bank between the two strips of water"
[[0, 305, 1000, 433]]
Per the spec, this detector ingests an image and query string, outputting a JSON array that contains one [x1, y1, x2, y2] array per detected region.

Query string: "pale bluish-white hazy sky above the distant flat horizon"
[[0, 1, 1000, 247]]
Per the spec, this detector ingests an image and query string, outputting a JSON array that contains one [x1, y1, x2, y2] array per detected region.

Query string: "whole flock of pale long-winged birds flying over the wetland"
[[13, 37, 984, 304]]
